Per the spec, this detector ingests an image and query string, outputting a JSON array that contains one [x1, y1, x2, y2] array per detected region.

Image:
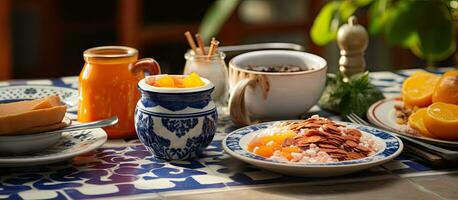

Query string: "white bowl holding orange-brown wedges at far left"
[[0, 93, 76, 155]]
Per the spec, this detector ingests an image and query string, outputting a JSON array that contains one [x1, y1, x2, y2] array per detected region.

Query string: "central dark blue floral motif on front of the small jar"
[[161, 117, 199, 138]]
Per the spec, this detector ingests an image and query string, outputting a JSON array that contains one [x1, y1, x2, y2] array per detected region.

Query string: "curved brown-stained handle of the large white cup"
[[228, 77, 256, 126]]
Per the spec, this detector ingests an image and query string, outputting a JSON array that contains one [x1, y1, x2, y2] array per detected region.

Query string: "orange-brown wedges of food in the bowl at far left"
[[0, 96, 67, 135]]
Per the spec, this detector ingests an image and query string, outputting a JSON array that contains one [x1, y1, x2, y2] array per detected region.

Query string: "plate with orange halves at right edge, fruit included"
[[367, 70, 458, 147]]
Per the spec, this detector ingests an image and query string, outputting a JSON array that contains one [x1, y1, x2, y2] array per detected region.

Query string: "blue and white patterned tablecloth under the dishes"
[[0, 70, 457, 199]]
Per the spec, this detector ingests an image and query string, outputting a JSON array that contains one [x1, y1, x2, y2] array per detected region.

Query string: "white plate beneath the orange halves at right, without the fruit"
[[367, 98, 458, 147]]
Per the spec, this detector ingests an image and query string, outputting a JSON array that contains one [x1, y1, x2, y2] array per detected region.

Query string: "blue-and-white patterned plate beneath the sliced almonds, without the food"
[[223, 122, 403, 177]]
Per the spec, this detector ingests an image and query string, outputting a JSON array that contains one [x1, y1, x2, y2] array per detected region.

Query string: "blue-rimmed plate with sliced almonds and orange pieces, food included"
[[223, 116, 403, 177]]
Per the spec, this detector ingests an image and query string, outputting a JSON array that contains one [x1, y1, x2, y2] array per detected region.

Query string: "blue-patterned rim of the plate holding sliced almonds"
[[223, 120, 404, 168]]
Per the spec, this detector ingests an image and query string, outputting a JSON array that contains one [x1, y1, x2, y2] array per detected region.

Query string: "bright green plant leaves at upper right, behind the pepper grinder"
[[310, 0, 457, 61]]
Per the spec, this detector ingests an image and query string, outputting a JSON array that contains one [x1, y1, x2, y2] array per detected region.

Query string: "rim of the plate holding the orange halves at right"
[[367, 98, 458, 146]]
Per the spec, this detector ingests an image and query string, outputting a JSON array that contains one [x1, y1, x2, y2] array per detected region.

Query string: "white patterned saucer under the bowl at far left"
[[0, 128, 107, 167]]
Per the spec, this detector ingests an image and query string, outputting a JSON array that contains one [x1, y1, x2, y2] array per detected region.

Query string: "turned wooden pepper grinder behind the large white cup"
[[337, 16, 369, 82]]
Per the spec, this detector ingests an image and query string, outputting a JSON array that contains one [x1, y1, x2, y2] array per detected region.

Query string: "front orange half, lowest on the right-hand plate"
[[423, 102, 458, 140]]
